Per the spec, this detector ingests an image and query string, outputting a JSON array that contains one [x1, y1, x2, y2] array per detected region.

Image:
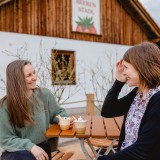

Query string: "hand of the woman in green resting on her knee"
[[31, 145, 49, 160]]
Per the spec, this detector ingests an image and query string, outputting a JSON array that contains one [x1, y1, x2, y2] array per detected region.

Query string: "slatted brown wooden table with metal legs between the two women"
[[45, 116, 123, 160]]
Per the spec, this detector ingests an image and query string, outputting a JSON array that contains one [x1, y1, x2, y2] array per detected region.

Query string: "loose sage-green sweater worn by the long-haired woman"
[[0, 88, 68, 152]]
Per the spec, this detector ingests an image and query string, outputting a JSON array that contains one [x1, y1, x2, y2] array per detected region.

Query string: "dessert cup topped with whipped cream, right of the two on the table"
[[74, 116, 87, 134]]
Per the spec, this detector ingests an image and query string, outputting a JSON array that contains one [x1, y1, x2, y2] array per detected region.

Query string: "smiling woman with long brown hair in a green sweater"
[[0, 60, 73, 160]]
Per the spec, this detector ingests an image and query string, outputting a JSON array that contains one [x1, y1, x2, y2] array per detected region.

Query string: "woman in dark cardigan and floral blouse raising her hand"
[[98, 42, 160, 160]]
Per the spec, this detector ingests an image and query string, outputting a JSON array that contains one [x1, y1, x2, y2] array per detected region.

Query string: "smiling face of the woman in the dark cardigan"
[[122, 60, 140, 87]]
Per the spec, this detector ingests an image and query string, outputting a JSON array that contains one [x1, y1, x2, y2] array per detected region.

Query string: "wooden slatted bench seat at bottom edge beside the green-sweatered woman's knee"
[[52, 151, 74, 160]]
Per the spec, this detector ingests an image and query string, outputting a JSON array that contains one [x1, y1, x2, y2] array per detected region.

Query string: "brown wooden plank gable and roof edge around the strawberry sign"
[[0, 0, 160, 45]]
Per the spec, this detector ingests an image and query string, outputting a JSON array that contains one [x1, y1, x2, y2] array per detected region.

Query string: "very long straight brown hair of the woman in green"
[[1, 60, 34, 128]]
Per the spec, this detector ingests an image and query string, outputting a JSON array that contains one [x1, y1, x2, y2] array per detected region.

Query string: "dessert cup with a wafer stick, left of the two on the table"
[[56, 115, 71, 130]]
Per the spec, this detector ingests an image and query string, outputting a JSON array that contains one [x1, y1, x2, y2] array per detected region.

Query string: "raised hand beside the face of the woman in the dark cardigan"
[[116, 59, 127, 82]]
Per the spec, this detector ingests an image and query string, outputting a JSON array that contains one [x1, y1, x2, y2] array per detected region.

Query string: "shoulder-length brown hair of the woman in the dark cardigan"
[[123, 42, 160, 88]]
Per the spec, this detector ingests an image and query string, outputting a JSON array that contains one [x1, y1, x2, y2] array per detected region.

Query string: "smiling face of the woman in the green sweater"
[[23, 64, 37, 91]]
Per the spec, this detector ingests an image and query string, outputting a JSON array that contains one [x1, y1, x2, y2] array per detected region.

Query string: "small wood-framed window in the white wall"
[[52, 50, 76, 85]]
